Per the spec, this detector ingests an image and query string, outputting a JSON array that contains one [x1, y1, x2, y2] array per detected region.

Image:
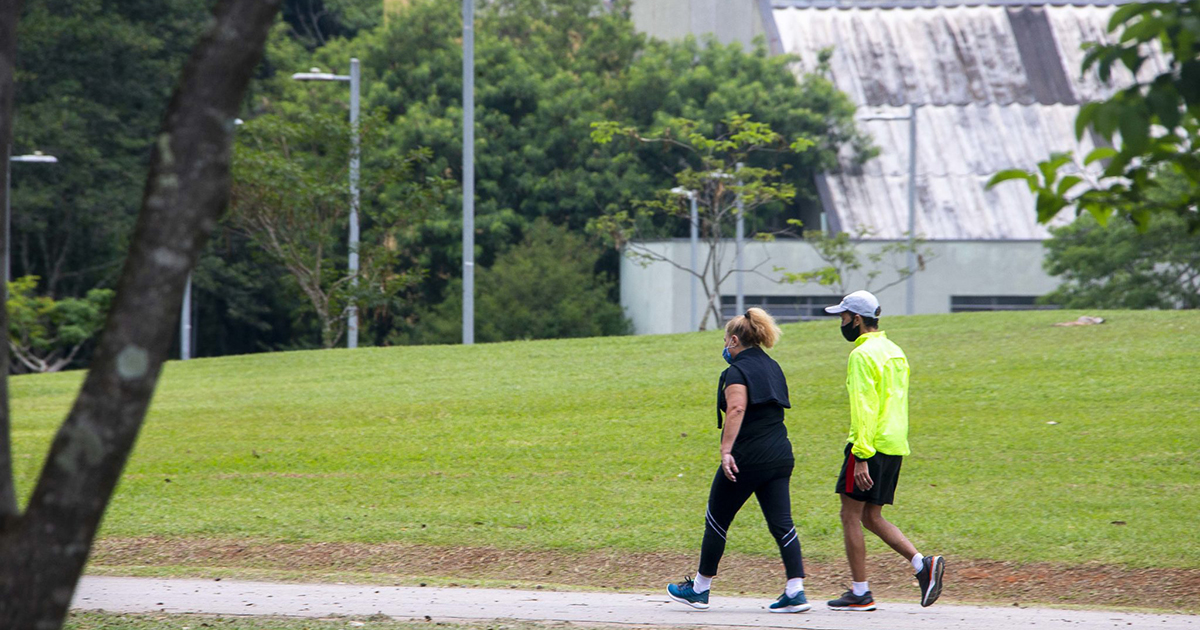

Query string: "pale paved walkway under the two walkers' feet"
[[72, 576, 1200, 630]]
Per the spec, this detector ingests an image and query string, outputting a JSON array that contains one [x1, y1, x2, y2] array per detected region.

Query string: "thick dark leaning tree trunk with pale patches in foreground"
[[0, 0, 281, 630]]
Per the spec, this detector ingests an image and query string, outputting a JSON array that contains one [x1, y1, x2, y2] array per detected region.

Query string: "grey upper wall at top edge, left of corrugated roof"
[[632, 0, 766, 46]]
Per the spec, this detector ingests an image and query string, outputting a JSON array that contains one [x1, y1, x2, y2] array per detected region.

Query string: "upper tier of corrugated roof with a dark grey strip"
[[774, 6, 1165, 106]]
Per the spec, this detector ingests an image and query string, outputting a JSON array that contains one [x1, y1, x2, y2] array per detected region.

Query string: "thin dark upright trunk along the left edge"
[[0, 0, 20, 520]]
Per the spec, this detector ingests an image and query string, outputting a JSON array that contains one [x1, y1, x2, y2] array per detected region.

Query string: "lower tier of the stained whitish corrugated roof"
[[823, 104, 1092, 240]]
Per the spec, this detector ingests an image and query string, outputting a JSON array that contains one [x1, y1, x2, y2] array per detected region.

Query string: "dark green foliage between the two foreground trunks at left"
[[11, 0, 210, 296]]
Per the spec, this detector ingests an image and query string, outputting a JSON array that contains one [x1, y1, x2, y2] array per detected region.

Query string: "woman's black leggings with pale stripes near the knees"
[[700, 463, 804, 580]]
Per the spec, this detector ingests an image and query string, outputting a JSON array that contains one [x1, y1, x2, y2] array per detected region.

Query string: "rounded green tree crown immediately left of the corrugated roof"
[[611, 37, 877, 232]]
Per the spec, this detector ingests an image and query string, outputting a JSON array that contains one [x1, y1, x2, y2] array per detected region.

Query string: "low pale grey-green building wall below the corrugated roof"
[[620, 239, 1058, 335]]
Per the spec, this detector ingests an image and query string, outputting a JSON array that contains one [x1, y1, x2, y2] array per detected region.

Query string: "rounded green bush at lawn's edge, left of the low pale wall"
[[418, 220, 630, 343]]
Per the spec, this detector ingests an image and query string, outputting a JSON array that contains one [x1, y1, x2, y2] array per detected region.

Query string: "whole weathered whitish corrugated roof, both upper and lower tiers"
[[773, 0, 1165, 240]]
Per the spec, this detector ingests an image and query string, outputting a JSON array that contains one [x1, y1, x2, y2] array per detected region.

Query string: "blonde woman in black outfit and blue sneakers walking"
[[667, 308, 811, 612]]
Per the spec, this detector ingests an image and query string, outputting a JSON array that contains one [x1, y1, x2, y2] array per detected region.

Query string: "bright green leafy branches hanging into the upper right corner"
[[989, 0, 1200, 234]]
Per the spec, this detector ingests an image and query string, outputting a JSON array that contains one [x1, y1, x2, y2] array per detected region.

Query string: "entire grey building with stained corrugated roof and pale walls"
[[620, 0, 1165, 334]]
